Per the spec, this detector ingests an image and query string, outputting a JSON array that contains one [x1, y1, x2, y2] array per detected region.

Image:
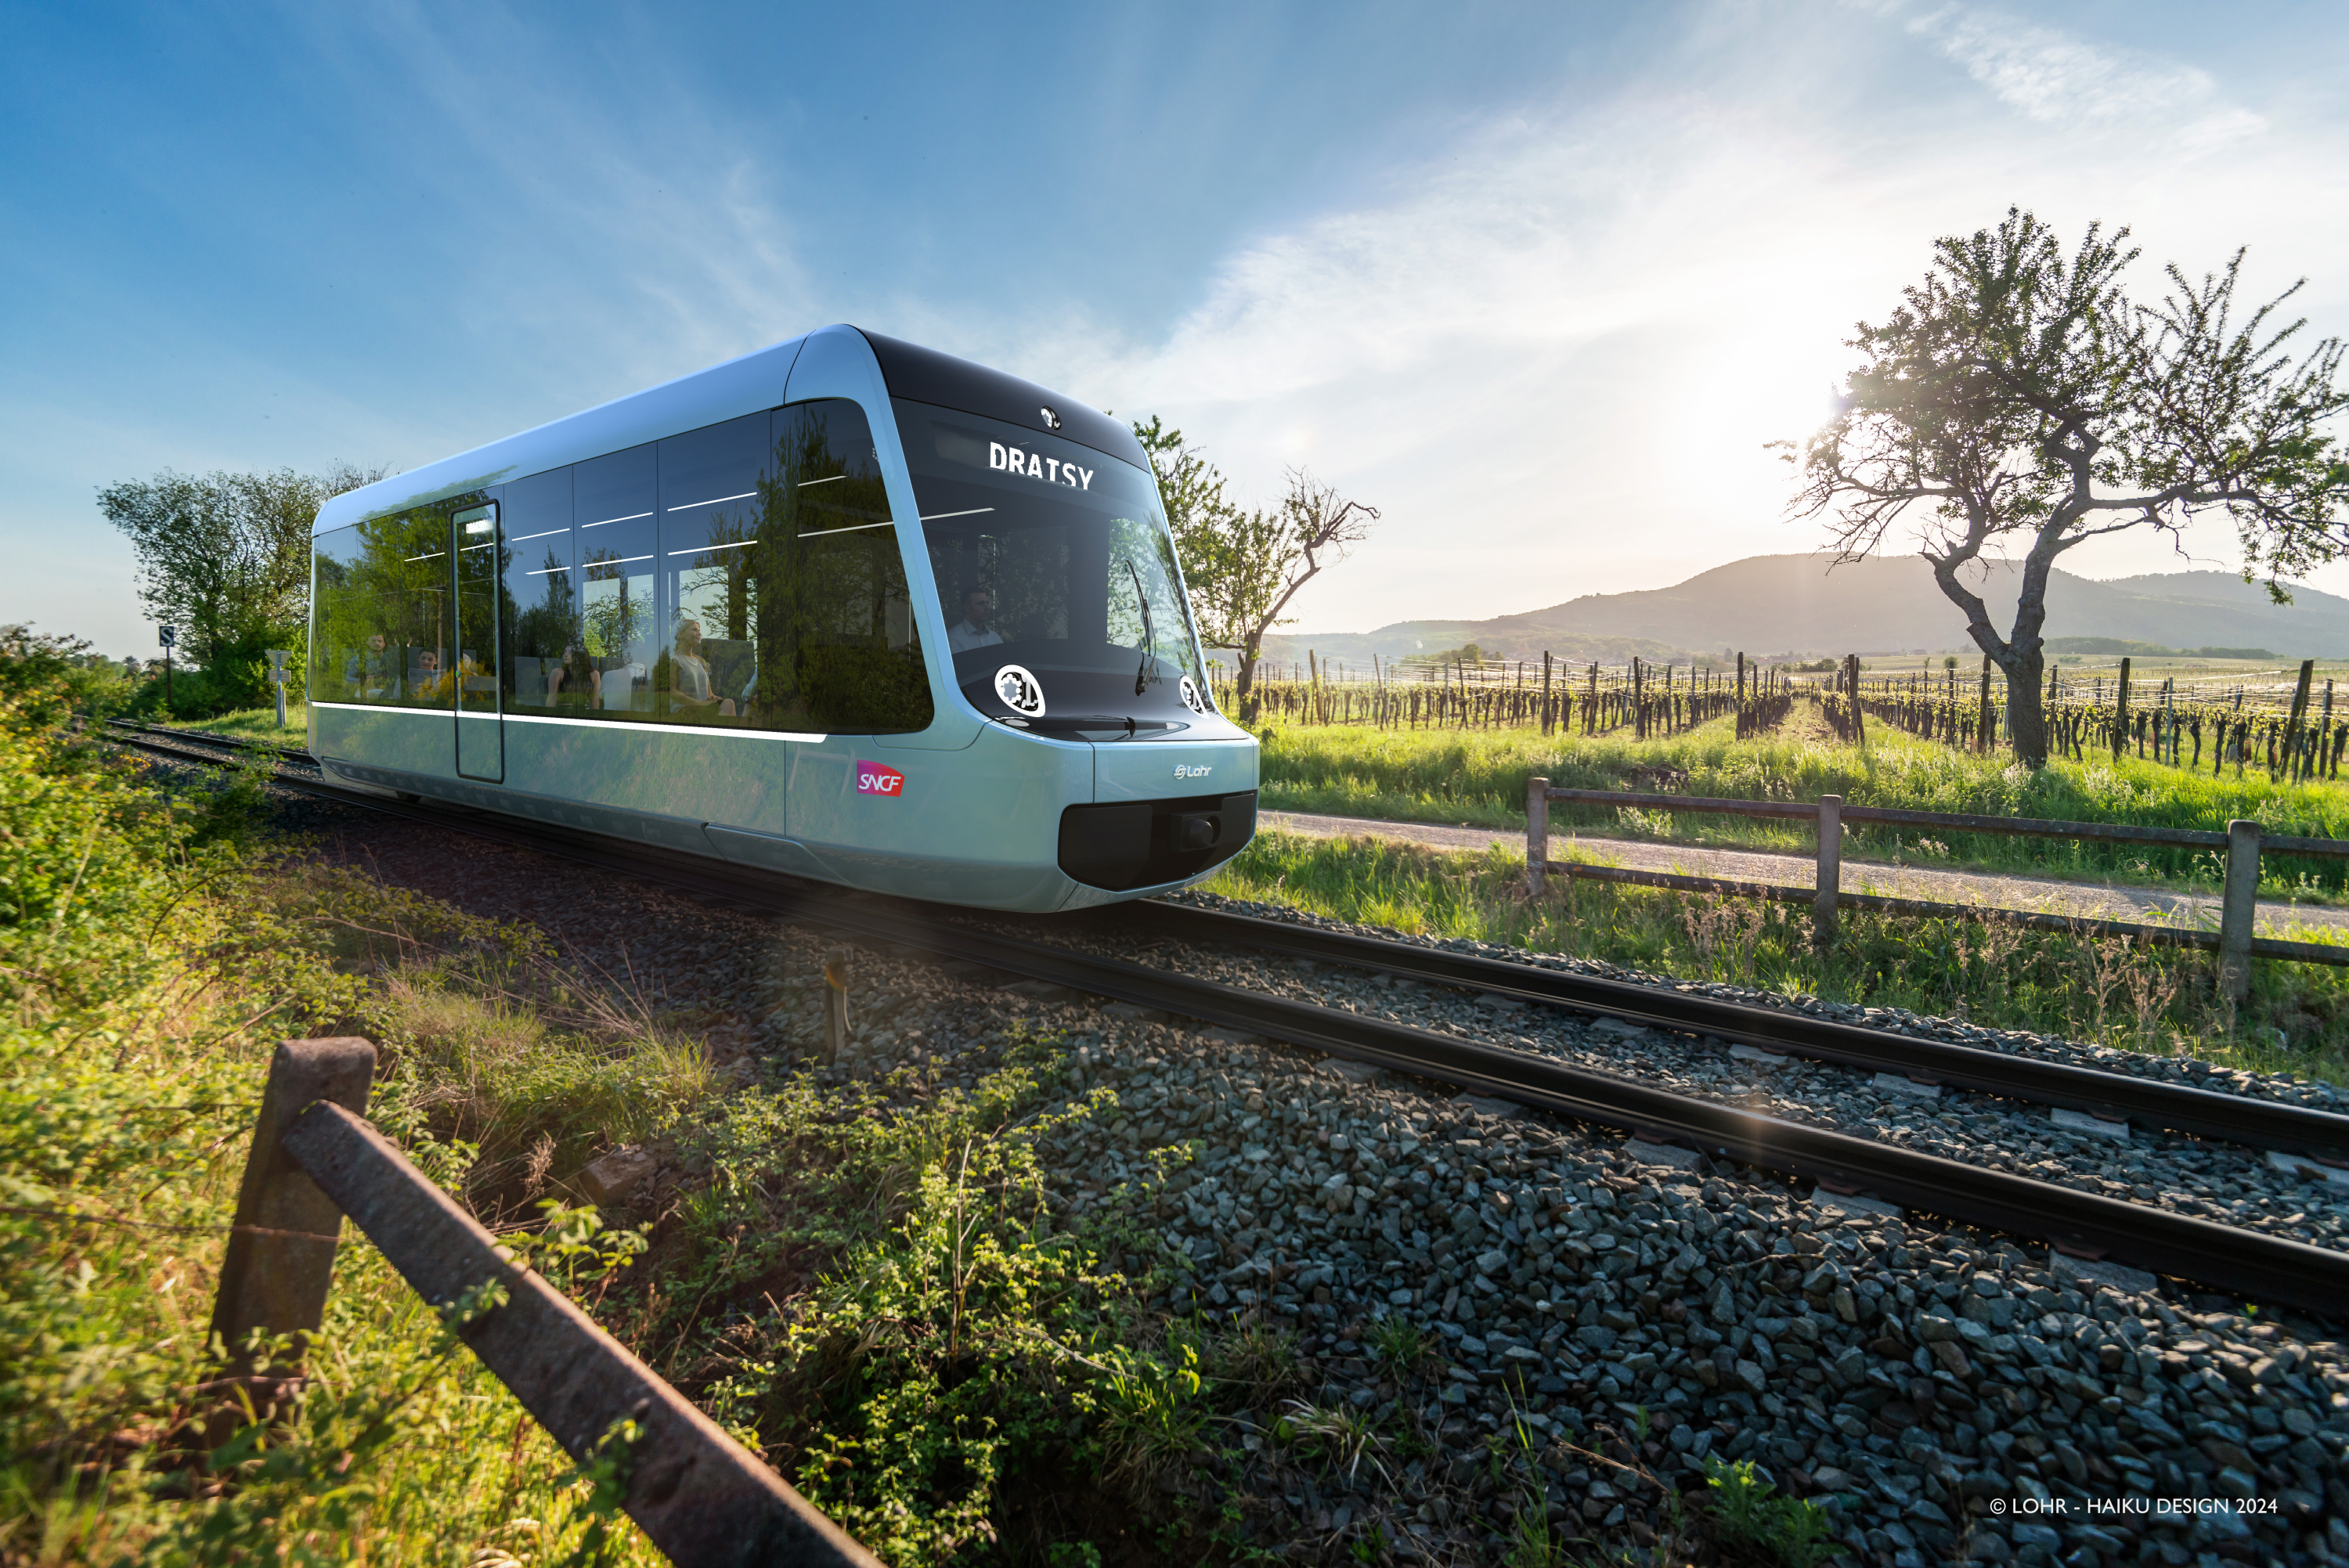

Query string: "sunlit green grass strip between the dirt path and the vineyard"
[[1261, 707, 2349, 903]]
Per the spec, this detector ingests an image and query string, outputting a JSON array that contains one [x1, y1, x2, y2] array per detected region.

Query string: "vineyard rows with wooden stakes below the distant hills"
[[1252, 655, 2349, 782]]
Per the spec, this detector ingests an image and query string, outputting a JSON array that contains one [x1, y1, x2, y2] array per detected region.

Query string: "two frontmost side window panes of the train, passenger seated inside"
[[655, 399, 935, 735]]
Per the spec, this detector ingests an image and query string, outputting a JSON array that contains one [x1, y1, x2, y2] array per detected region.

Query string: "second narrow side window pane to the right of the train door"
[[571, 444, 660, 716]]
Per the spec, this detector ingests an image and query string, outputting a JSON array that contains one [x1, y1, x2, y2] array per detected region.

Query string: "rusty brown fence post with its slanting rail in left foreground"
[[211, 1037, 879, 1568]]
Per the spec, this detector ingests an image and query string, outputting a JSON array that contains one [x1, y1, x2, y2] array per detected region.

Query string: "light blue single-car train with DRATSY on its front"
[[305, 326, 1259, 913]]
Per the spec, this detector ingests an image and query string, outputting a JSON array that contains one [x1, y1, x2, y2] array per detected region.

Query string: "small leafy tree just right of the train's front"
[[1135, 416, 1379, 723]]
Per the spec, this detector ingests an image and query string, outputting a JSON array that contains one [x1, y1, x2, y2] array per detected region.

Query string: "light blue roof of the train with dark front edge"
[[315, 324, 1149, 533]]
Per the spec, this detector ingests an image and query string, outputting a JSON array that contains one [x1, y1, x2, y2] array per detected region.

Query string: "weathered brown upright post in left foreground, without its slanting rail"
[[211, 1035, 376, 1378]]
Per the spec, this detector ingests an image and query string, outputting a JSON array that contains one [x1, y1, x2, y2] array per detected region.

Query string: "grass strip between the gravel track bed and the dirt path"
[[1207, 831, 2349, 1082]]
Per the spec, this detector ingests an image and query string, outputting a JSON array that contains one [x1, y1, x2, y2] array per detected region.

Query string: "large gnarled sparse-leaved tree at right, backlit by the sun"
[[1781, 209, 2349, 768]]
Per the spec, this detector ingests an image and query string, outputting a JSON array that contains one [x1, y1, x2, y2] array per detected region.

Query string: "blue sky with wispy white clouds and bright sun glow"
[[13, 2, 2349, 655]]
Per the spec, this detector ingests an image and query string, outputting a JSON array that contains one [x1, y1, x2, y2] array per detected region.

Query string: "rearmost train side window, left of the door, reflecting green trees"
[[310, 507, 456, 709]]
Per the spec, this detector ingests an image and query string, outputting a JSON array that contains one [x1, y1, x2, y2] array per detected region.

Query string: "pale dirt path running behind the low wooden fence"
[[1257, 812, 2349, 934]]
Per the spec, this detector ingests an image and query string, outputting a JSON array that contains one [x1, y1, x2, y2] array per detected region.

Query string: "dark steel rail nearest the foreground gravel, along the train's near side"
[[101, 723, 2349, 1312]]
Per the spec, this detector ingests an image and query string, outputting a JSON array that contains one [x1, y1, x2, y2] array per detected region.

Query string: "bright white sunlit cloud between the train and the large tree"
[[963, 12, 2342, 629]]
